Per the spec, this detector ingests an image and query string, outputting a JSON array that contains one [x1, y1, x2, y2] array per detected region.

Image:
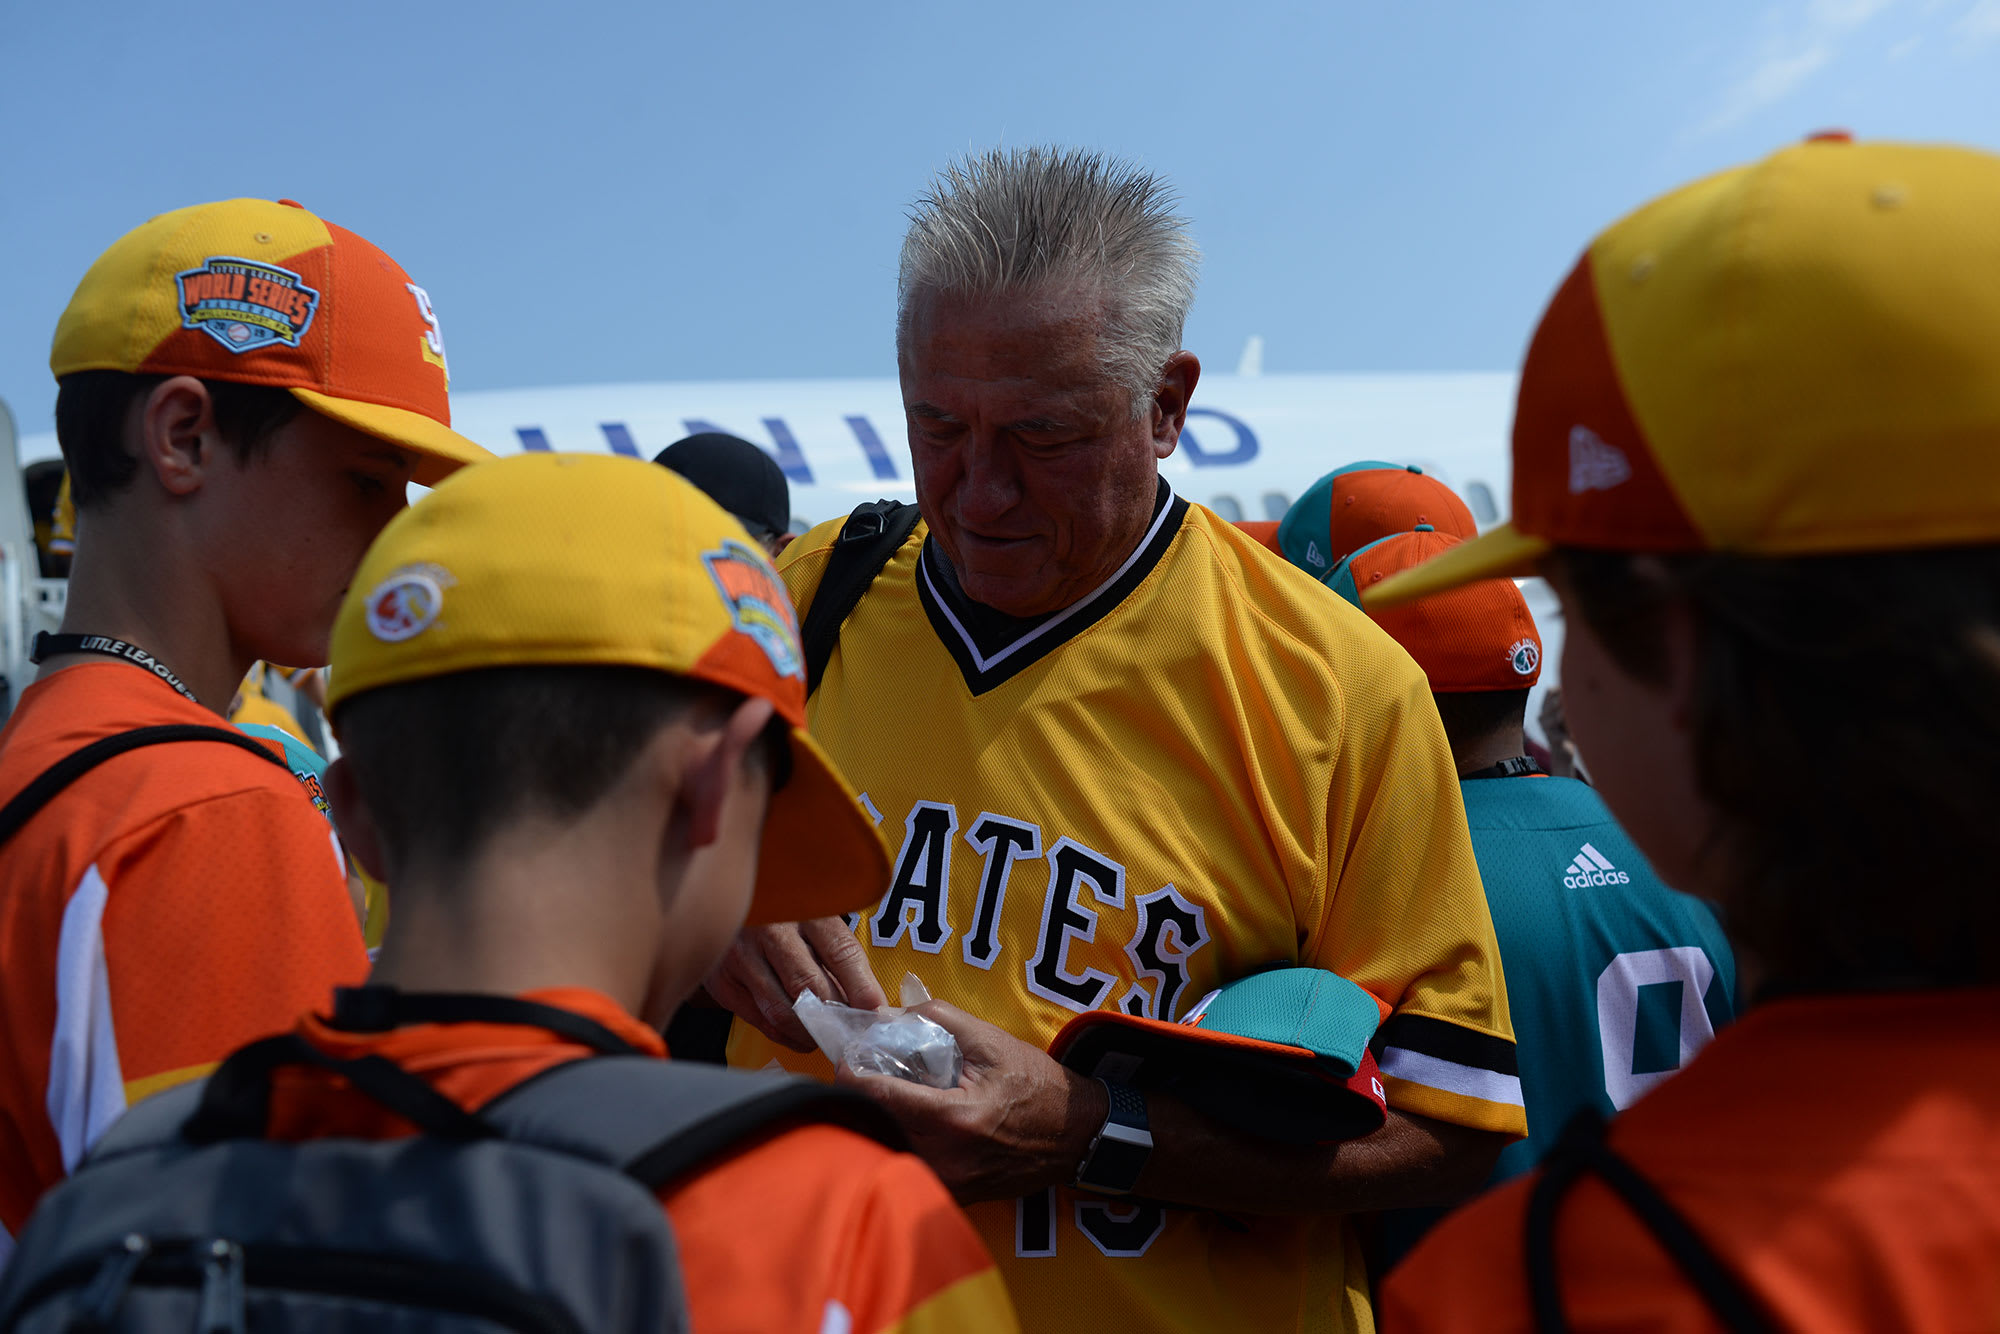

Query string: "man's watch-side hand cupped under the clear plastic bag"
[[838, 1000, 1110, 1204]]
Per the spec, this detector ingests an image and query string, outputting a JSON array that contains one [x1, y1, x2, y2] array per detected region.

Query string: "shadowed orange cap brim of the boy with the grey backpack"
[[748, 728, 890, 926]]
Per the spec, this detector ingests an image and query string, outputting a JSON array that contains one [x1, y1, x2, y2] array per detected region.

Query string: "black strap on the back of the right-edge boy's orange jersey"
[[1522, 1108, 1778, 1334]]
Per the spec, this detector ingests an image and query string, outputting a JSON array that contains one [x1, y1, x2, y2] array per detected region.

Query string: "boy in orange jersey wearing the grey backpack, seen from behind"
[[308, 456, 1016, 1334]]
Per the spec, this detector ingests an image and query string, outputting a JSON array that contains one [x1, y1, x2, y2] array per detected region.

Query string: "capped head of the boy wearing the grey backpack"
[[328, 454, 888, 976]]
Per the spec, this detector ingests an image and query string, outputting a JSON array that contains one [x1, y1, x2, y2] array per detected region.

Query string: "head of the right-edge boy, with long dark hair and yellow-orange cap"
[[1370, 140, 2000, 986]]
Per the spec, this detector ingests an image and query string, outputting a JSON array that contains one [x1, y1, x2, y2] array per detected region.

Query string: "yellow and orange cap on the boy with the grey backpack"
[[328, 454, 890, 922]]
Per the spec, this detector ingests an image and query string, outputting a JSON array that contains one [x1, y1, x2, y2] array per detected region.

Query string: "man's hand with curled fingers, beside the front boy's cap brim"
[[706, 918, 888, 1052]]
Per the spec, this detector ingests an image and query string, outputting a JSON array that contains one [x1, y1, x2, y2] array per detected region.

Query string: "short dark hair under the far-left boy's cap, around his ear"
[[56, 370, 304, 510]]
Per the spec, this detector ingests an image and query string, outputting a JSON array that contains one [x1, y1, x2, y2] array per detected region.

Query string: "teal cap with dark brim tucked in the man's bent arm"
[[1048, 968, 1388, 1144]]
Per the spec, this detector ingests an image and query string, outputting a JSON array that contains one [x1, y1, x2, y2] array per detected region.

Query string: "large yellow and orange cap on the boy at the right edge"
[[1368, 134, 2000, 610]]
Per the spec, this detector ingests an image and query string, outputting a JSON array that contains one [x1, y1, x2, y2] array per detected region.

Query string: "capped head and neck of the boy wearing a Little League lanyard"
[[50, 200, 488, 662]]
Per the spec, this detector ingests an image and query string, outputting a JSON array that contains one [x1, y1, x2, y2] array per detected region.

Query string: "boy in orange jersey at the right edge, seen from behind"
[[1368, 136, 2000, 1330]]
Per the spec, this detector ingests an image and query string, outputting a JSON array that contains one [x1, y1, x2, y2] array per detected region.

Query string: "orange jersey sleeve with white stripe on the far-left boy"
[[0, 756, 368, 1230]]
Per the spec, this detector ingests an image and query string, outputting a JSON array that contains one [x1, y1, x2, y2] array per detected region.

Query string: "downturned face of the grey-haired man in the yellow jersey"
[[900, 292, 1194, 616]]
